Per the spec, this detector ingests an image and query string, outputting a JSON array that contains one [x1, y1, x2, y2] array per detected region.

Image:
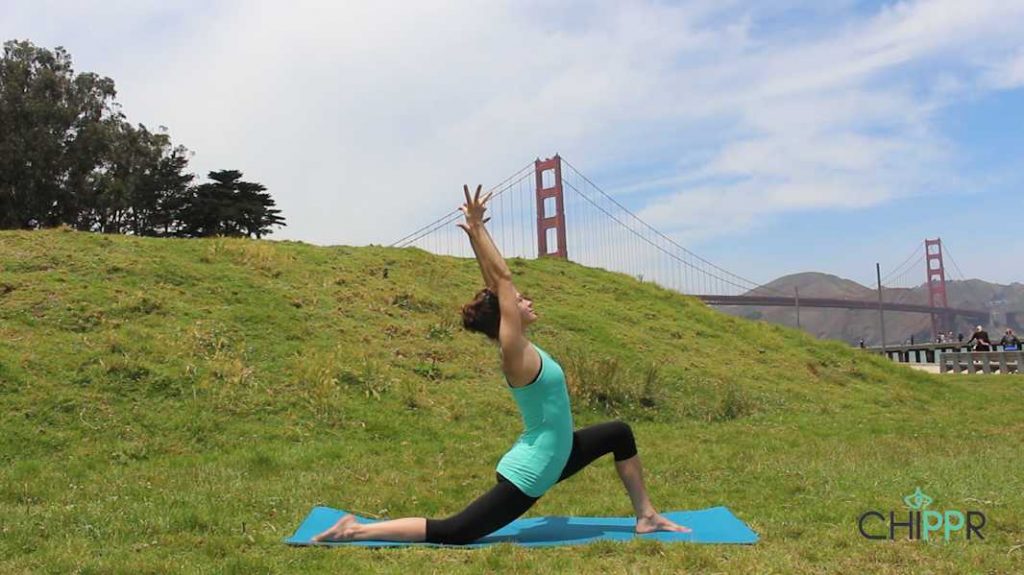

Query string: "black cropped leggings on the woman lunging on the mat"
[[427, 422, 637, 545]]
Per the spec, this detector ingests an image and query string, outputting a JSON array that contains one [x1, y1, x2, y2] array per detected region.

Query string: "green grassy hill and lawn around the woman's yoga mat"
[[0, 230, 1024, 574]]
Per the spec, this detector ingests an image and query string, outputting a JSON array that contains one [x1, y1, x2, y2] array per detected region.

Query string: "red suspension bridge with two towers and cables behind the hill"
[[392, 156, 999, 334]]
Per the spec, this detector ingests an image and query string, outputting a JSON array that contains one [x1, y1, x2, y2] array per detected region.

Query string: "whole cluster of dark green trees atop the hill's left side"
[[0, 40, 285, 238]]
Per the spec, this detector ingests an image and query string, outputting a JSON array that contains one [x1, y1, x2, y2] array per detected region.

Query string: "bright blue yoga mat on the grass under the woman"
[[285, 501, 758, 547]]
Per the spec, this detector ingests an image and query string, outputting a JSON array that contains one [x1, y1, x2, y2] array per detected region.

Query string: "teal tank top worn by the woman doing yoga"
[[498, 344, 572, 497]]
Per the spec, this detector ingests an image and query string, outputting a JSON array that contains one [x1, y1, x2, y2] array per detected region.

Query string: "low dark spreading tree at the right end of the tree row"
[[179, 170, 285, 239]]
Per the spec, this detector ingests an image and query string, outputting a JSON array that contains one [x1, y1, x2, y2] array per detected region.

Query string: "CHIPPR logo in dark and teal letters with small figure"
[[857, 487, 987, 541]]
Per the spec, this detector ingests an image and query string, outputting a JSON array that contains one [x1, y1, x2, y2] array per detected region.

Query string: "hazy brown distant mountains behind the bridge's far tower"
[[717, 272, 1024, 345]]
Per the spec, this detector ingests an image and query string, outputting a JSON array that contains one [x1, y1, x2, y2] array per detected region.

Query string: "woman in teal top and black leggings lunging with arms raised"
[[313, 186, 690, 545]]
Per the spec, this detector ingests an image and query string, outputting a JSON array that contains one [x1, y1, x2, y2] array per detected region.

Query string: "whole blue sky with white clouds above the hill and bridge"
[[6, 0, 1024, 283]]
